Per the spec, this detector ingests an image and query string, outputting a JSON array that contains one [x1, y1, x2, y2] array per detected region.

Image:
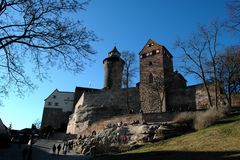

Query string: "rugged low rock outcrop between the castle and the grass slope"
[[75, 123, 191, 154]]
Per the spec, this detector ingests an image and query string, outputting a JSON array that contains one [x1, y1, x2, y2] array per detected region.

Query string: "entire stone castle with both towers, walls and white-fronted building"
[[42, 39, 240, 134]]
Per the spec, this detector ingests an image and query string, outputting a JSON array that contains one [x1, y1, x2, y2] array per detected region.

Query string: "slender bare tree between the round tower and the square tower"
[[122, 51, 137, 111]]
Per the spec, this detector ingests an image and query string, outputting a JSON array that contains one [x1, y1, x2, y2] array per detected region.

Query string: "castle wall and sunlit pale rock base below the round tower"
[[67, 88, 140, 134]]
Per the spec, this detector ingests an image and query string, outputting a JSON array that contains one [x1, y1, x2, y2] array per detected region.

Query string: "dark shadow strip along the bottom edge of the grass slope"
[[96, 151, 240, 160]]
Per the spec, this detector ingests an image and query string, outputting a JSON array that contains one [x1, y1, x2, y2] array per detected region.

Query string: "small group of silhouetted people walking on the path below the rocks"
[[52, 141, 73, 155]]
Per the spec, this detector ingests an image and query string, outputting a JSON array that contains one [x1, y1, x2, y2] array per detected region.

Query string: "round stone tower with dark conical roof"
[[103, 47, 125, 89]]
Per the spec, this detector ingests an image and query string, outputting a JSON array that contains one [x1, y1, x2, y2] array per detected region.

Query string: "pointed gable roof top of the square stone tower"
[[139, 39, 173, 58]]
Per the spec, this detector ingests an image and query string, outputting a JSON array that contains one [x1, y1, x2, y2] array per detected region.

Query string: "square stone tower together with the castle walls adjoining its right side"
[[139, 39, 214, 112]]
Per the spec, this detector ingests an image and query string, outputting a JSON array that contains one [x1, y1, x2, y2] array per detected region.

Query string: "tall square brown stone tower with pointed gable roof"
[[139, 39, 173, 112]]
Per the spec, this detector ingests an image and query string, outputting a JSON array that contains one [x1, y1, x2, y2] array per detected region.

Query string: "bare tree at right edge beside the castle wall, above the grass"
[[217, 46, 240, 107]]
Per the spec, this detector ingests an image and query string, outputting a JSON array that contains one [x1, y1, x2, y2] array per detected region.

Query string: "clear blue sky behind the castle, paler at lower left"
[[0, 0, 233, 129]]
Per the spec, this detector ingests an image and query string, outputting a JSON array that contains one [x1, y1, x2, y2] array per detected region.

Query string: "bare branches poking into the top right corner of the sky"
[[227, 0, 240, 32]]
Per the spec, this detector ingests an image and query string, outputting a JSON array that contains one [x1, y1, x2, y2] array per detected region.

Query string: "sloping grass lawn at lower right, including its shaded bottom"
[[97, 115, 240, 160]]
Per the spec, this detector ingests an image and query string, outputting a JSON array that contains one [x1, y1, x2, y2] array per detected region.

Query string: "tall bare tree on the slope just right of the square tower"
[[176, 20, 224, 107]]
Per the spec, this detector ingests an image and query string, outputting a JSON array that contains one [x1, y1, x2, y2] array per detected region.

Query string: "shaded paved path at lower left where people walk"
[[0, 141, 92, 160]]
